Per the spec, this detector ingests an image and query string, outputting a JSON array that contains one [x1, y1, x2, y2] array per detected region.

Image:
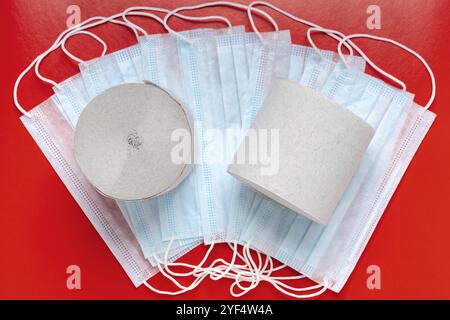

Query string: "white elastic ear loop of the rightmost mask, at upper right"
[[338, 33, 436, 110]]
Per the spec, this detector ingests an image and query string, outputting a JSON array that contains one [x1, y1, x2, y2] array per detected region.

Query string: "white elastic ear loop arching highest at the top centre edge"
[[164, 1, 279, 43]]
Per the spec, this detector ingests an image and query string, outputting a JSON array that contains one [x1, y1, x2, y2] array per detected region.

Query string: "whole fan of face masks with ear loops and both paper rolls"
[[14, 1, 436, 298]]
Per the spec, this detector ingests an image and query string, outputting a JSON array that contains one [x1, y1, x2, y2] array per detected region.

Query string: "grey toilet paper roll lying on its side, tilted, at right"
[[228, 79, 374, 225]]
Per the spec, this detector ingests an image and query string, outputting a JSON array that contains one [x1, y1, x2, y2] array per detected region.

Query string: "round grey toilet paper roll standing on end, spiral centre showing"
[[75, 83, 194, 200]]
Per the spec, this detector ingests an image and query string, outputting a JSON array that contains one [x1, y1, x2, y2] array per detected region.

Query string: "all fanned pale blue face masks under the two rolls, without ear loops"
[[16, 5, 435, 292]]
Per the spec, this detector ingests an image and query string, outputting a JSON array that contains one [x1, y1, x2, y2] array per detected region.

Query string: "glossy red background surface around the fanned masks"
[[0, 0, 450, 299]]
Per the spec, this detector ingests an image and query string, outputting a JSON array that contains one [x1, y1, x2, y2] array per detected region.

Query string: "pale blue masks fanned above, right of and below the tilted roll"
[[232, 41, 435, 292]]
